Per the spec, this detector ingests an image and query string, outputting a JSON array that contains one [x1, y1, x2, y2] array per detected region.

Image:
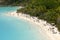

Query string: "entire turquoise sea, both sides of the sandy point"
[[0, 7, 46, 40]]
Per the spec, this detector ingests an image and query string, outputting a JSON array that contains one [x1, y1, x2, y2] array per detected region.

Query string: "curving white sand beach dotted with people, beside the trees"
[[5, 11, 60, 40]]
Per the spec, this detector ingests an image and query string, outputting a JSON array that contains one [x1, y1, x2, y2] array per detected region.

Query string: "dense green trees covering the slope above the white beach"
[[17, 0, 60, 31]]
